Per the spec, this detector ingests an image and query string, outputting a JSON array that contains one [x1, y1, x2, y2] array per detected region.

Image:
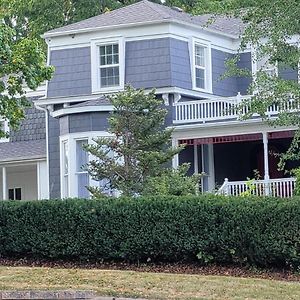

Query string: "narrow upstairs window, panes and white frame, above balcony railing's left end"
[[192, 40, 212, 93]]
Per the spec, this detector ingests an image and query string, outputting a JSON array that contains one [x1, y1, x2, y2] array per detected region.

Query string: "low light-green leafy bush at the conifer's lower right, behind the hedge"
[[142, 164, 201, 196]]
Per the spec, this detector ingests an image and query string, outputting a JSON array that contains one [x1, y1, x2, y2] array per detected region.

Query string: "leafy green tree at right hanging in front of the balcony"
[[227, 0, 300, 168]]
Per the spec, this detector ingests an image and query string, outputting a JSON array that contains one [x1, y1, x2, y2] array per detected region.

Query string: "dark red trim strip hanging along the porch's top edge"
[[179, 130, 294, 145]]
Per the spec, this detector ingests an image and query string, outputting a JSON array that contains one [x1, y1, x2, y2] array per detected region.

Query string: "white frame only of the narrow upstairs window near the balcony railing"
[[190, 37, 212, 94]]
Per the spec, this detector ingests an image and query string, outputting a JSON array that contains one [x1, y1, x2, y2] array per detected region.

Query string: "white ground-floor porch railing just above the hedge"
[[217, 178, 296, 198]]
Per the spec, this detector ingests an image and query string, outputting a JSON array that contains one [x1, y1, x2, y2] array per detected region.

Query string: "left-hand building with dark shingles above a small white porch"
[[0, 87, 49, 200]]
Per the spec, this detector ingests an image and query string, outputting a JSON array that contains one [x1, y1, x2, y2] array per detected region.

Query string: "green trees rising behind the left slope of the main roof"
[[0, 0, 160, 39]]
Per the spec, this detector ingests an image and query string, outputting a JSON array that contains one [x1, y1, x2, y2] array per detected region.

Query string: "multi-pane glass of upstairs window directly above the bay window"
[[99, 44, 120, 88]]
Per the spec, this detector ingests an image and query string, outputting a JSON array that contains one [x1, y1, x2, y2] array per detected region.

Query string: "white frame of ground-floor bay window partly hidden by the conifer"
[[60, 131, 112, 198]]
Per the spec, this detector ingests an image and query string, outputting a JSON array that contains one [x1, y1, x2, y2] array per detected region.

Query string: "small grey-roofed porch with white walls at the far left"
[[0, 140, 49, 200]]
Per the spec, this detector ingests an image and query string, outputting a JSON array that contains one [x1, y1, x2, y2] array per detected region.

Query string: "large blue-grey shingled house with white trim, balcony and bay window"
[[0, 0, 298, 198]]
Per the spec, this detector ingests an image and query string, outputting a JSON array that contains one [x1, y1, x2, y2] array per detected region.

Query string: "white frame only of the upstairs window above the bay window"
[[91, 37, 125, 94]]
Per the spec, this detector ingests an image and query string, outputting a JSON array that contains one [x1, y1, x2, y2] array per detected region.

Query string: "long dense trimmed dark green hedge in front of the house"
[[0, 195, 300, 267]]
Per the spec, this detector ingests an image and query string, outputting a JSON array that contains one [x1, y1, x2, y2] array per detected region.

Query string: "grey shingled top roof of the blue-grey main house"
[[44, 0, 244, 38]]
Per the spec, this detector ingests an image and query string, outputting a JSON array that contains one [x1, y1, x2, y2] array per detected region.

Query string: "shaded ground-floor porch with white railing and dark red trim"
[[178, 131, 299, 197]]
